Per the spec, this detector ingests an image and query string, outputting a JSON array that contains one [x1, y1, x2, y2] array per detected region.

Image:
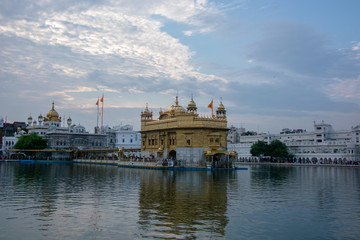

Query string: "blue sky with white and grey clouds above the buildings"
[[0, 0, 360, 133]]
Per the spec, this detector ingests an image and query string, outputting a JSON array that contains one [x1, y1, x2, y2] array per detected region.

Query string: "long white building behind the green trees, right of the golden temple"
[[228, 121, 360, 163]]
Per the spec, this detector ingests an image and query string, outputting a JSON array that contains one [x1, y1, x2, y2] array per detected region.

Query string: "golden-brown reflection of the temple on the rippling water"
[[138, 171, 233, 239]]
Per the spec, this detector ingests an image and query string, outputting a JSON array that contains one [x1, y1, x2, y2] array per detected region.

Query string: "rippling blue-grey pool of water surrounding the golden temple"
[[0, 163, 360, 240]]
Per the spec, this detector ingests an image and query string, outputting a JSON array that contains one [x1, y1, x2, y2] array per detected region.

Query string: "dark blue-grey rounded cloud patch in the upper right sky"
[[248, 22, 343, 76]]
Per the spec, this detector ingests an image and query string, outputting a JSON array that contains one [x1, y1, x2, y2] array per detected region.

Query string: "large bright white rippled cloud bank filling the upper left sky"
[[0, 1, 231, 100]]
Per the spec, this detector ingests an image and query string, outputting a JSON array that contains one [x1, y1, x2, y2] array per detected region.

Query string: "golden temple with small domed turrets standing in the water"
[[140, 96, 228, 166]]
